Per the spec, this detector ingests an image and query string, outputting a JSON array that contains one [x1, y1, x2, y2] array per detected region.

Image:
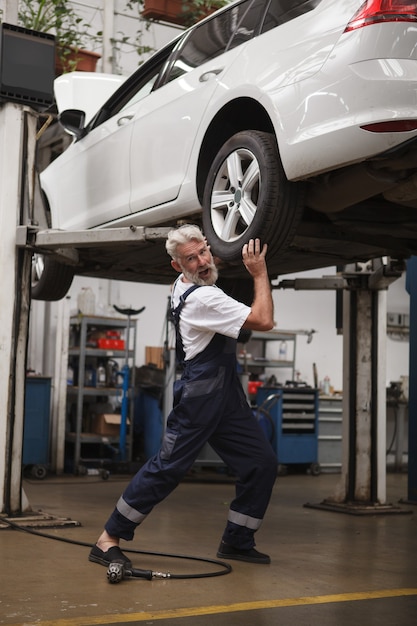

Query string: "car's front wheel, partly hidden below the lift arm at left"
[[31, 254, 74, 301]]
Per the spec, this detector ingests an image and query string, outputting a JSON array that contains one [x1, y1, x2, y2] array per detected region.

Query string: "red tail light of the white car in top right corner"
[[345, 0, 417, 32]]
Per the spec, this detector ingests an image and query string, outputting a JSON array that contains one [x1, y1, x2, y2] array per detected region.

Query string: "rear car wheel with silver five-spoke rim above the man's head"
[[203, 130, 303, 262]]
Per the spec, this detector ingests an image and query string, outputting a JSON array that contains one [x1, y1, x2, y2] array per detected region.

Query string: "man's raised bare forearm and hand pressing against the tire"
[[242, 239, 274, 330]]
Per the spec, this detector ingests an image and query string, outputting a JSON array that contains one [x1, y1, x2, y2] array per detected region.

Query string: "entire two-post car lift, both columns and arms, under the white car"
[[0, 102, 417, 515]]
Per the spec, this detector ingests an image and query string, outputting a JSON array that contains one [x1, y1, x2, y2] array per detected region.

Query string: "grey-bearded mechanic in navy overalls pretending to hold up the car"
[[89, 225, 277, 567]]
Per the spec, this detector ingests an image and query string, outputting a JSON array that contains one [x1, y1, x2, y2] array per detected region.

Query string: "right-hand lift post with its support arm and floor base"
[[274, 259, 411, 515]]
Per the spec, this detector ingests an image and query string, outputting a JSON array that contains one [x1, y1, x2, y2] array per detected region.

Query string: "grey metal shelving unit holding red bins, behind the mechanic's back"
[[65, 315, 136, 473]]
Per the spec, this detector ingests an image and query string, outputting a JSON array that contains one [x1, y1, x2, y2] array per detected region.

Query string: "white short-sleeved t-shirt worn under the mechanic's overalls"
[[172, 274, 251, 361]]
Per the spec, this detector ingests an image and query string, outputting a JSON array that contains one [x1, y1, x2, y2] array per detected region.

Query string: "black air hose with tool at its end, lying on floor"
[[0, 517, 232, 583]]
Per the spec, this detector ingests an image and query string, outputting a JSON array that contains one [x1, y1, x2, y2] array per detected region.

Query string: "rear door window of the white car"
[[167, 0, 253, 81]]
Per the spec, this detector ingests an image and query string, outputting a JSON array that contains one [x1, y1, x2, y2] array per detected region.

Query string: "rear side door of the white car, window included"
[[130, 0, 255, 213]]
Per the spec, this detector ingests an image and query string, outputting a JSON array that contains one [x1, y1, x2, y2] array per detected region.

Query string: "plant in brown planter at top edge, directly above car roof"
[[142, 0, 228, 27]]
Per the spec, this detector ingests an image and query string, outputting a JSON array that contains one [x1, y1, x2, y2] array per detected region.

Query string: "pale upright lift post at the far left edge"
[[0, 103, 36, 514]]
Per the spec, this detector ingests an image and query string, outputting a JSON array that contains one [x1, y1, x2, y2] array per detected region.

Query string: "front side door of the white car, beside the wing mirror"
[[43, 45, 174, 229]]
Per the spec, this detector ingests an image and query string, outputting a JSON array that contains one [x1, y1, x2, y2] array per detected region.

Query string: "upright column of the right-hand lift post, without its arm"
[[335, 289, 386, 507]]
